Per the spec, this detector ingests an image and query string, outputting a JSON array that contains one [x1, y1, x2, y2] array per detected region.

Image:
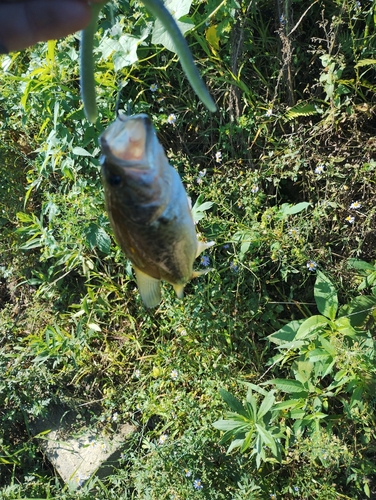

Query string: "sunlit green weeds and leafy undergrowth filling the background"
[[0, 0, 376, 500]]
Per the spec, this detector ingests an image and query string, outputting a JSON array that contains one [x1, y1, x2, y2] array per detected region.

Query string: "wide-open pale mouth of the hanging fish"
[[100, 114, 152, 168]]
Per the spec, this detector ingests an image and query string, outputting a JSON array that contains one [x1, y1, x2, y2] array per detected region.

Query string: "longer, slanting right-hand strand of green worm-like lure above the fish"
[[142, 0, 217, 113]]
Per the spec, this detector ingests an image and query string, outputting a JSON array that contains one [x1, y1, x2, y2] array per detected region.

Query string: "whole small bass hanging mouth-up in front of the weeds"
[[99, 114, 214, 308]]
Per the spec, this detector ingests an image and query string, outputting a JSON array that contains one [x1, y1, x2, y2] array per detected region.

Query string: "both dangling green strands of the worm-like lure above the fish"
[[80, 0, 217, 123]]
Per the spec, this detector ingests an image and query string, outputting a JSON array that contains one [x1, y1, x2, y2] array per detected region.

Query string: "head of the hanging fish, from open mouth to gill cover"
[[99, 114, 171, 224]]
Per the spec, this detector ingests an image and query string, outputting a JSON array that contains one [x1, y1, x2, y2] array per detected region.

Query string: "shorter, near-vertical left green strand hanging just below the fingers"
[[80, 0, 109, 123]]
